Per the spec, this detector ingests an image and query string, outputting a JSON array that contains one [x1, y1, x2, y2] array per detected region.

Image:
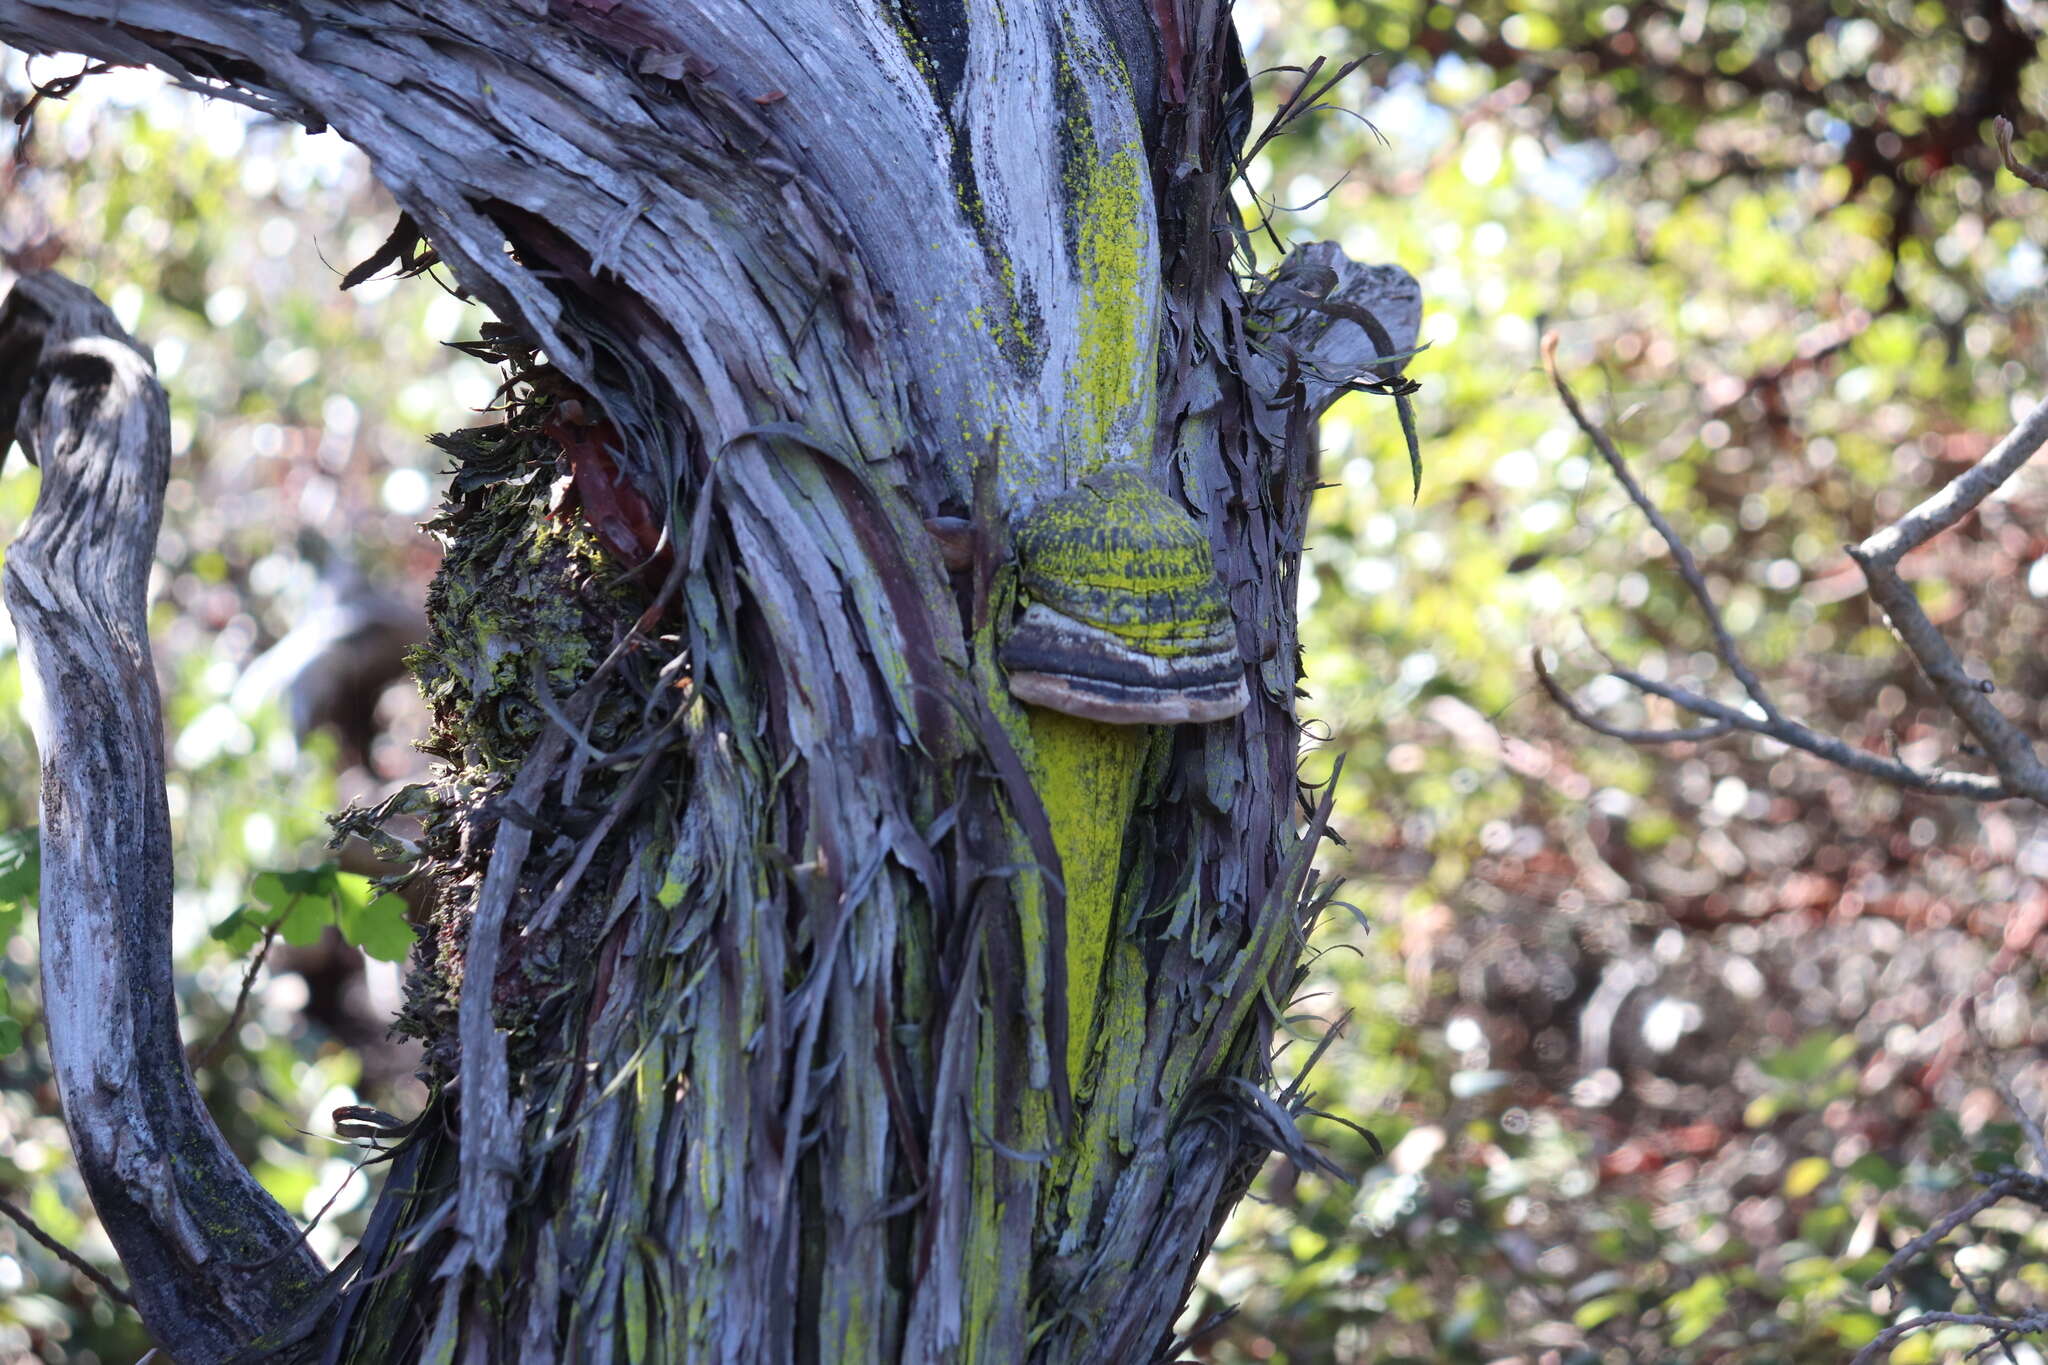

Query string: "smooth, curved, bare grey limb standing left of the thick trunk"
[[0, 274, 324, 1365]]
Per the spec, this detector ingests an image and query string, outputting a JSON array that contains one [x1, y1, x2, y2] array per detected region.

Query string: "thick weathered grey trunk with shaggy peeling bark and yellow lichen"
[[0, 0, 1415, 1363]]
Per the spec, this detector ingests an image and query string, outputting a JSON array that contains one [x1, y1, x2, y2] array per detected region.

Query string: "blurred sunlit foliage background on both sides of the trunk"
[[0, 0, 2048, 1365]]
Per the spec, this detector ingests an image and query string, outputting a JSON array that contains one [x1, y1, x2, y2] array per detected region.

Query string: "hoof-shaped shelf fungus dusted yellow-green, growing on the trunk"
[[999, 469, 1249, 724]]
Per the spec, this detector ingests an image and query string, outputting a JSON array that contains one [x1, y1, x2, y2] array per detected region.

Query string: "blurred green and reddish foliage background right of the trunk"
[[1202, 0, 2048, 1365]]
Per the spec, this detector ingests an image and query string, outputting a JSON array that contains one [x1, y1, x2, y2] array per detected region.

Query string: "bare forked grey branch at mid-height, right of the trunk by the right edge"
[[1536, 334, 2048, 806]]
